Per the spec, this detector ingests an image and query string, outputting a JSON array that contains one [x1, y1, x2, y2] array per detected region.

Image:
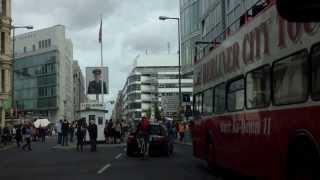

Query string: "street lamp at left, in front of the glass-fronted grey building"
[[11, 25, 33, 120]]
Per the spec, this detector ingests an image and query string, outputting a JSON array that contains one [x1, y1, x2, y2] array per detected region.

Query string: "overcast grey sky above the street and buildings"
[[12, 0, 179, 112]]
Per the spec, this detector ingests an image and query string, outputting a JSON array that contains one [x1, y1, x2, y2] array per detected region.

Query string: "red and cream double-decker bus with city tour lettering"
[[192, 1, 320, 179]]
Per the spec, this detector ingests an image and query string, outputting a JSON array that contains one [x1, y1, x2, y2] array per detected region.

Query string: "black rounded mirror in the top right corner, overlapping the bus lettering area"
[[276, 0, 320, 22]]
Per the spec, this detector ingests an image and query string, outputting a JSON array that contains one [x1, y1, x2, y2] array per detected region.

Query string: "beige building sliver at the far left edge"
[[0, 0, 12, 127]]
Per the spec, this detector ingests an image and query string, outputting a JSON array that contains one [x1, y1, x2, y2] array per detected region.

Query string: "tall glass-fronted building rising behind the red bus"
[[180, 0, 271, 69]]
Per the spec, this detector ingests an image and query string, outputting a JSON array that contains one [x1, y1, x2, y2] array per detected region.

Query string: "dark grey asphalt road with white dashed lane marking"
[[0, 139, 234, 180]]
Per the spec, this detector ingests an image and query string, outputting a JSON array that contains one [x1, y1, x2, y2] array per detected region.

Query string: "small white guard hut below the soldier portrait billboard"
[[80, 102, 108, 141]]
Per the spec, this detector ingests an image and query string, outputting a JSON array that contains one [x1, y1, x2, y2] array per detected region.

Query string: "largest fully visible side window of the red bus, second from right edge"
[[272, 50, 309, 105]]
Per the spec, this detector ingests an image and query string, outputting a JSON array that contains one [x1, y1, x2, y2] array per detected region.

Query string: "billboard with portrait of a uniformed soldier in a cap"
[[86, 67, 109, 94]]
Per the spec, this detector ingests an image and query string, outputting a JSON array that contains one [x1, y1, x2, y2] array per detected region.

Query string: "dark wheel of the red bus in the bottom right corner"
[[288, 138, 320, 180]]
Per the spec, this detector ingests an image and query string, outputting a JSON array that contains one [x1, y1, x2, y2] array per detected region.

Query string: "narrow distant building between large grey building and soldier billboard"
[[72, 61, 86, 119]]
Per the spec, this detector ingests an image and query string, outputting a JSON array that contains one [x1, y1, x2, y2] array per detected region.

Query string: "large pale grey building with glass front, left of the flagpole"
[[14, 25, 74, 122]]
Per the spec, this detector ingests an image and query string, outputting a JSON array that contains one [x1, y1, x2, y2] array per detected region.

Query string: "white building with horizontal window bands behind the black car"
[[122, 54, 193, 120]]
